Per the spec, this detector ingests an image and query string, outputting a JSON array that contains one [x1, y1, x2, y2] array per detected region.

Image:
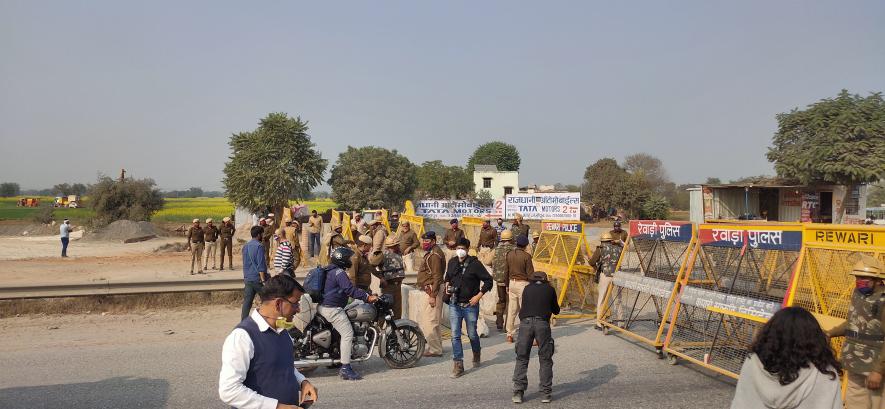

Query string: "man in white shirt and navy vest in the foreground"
[[218, 274, 317, 409]]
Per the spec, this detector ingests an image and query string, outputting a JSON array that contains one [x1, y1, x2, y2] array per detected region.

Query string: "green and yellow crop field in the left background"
[[0, 197, 335, 224]]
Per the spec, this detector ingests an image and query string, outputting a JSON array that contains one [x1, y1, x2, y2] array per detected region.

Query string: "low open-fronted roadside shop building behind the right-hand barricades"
[[688, 180, 867, 224]]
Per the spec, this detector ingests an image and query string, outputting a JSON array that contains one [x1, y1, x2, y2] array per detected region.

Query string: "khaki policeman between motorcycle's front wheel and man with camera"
[[416, 231, 446, 357]]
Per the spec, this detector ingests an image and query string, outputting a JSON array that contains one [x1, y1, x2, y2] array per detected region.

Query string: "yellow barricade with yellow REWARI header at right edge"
[[787, 223, 885, 356]]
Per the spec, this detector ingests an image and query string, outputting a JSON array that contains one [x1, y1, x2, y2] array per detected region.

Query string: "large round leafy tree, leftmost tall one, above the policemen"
[[222, 112, 327, 212]]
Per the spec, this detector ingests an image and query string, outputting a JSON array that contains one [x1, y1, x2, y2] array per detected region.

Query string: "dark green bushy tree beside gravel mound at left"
[[89, 176, 164, 224]]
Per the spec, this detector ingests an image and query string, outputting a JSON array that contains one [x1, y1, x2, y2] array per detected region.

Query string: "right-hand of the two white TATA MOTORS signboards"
[[504, 192, 581, 220]]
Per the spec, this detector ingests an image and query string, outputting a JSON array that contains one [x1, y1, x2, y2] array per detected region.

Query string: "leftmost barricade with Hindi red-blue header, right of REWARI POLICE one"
[[599, 220, 695, 356]]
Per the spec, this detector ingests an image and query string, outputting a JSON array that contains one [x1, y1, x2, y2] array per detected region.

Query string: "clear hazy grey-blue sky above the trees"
[[0, 0, 885, 190]]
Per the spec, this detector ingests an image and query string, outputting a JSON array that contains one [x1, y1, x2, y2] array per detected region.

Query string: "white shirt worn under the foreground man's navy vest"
[[218, 309, 305, 409]]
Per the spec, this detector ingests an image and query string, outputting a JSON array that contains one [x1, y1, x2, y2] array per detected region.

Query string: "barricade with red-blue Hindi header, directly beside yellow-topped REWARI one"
[[664, 223, 802, 378]]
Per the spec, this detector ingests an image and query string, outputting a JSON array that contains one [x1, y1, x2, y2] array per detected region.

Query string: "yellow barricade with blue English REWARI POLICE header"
[[532, 220, 596, 318]]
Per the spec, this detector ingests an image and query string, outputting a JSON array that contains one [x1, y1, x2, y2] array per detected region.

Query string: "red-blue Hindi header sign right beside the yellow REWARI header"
[[698, 224, 802, 251]]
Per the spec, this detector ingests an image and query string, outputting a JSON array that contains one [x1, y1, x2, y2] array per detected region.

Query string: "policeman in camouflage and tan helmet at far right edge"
[[829, 255, 885, 409]]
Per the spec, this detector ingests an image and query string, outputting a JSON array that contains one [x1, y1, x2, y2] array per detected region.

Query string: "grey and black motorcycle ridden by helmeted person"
[[289, 294, 426, 372]]
